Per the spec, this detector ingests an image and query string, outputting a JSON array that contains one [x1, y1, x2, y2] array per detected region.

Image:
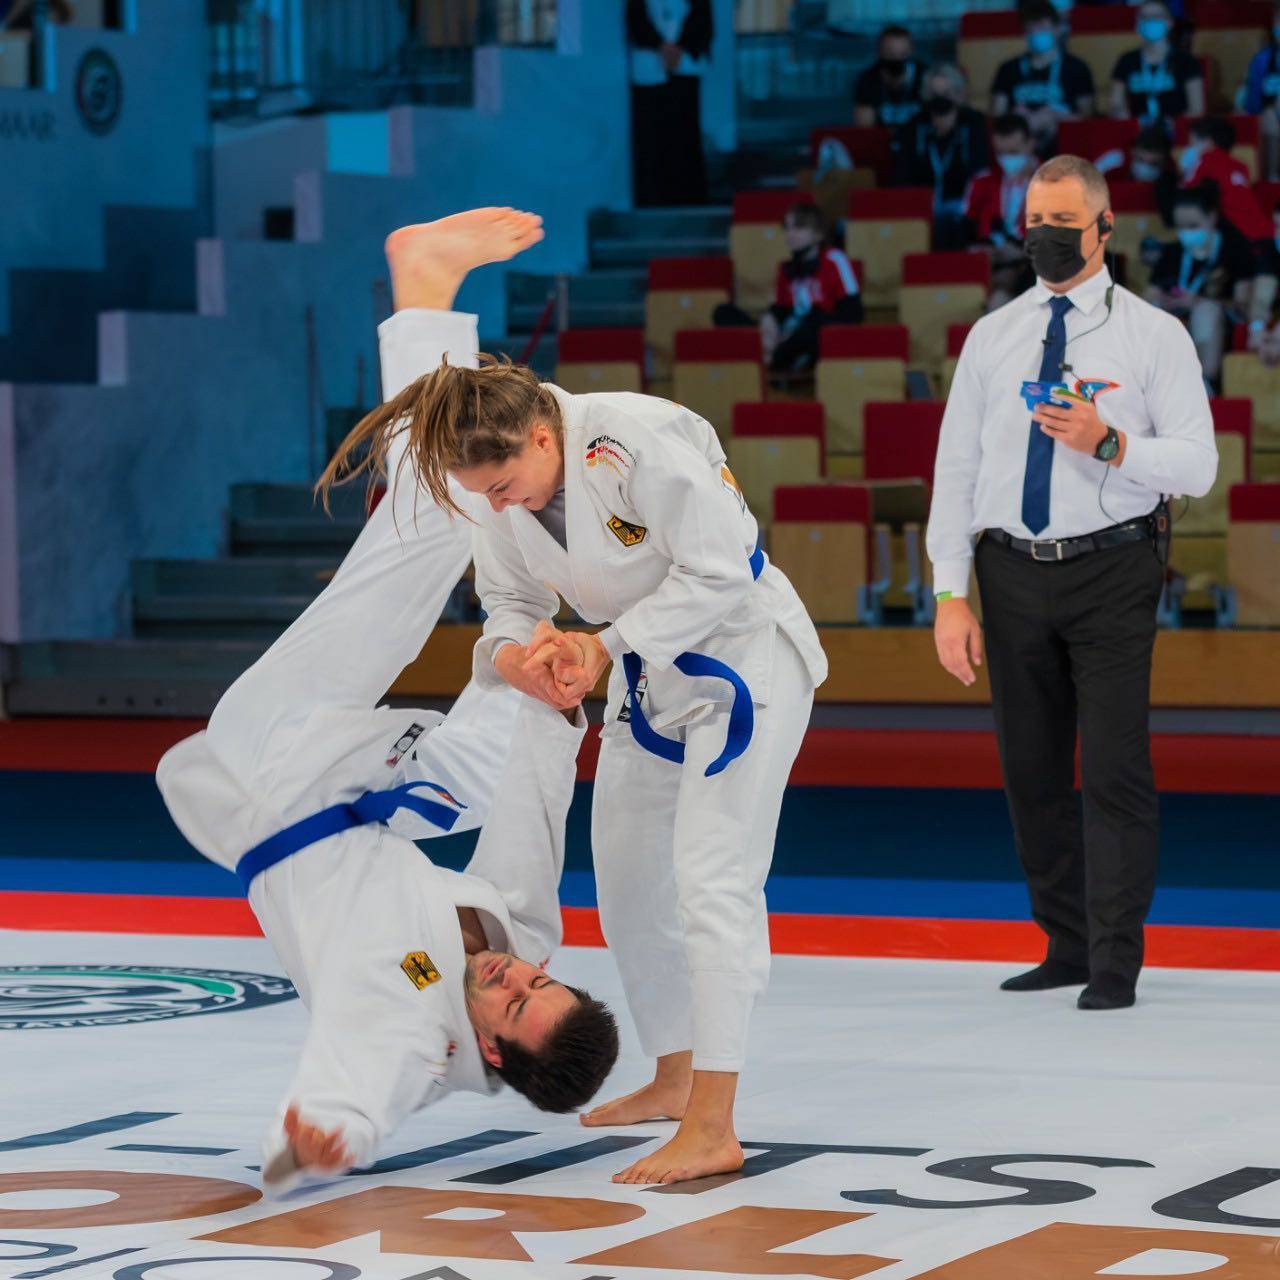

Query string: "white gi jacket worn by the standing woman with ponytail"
[[474, 385, 827, 736]]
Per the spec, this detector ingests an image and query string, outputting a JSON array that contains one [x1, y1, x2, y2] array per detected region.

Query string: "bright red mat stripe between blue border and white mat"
[[0, 892, 1280, 970]]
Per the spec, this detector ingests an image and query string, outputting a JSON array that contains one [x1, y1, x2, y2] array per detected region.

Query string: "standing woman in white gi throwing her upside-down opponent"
[[330, 277, 827, 1183]]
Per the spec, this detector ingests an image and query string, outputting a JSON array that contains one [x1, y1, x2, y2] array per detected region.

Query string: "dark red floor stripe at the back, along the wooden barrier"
[[0, 719, 1280, 795]]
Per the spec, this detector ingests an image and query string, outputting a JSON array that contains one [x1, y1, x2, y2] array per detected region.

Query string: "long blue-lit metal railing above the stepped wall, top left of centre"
[[207, 0, 558, 118]]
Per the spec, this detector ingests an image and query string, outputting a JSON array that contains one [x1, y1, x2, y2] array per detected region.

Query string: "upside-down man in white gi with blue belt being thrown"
[[157, 210, 617, 1190]]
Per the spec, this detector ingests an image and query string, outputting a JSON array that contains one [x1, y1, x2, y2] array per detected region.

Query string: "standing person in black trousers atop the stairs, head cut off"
[[627, 0, 713, 205]]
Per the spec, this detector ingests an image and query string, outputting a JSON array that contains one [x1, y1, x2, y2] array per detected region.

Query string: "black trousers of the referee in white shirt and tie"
[[975, 538, 1164, 982]]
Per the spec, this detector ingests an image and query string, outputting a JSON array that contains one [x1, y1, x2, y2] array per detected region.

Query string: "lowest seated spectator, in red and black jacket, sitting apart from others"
[[714, 204, 863, 374]]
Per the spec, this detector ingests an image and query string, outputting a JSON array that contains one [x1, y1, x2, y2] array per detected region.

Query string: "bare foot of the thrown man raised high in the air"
[[387, 209, 543, 311]]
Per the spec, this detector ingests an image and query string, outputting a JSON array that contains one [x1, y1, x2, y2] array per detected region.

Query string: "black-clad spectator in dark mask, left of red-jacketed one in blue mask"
[[893, 63, 991, 250]]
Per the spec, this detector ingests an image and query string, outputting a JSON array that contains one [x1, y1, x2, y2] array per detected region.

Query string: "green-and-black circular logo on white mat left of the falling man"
[[0, 964, 297, 1032]]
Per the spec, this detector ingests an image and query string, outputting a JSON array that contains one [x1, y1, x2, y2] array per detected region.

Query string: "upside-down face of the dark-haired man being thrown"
[[465, 951, 577, 1066]]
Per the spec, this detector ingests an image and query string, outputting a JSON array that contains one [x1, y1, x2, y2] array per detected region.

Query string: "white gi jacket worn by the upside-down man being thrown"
[[156, 694, 586, 1190]]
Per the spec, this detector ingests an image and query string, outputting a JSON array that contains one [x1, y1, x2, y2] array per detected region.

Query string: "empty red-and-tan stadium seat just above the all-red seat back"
[[815, 324, 910, 453]]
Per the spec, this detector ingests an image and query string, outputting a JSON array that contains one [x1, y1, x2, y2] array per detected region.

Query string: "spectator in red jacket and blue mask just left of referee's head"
[[965, 113, 1036, 311]]
